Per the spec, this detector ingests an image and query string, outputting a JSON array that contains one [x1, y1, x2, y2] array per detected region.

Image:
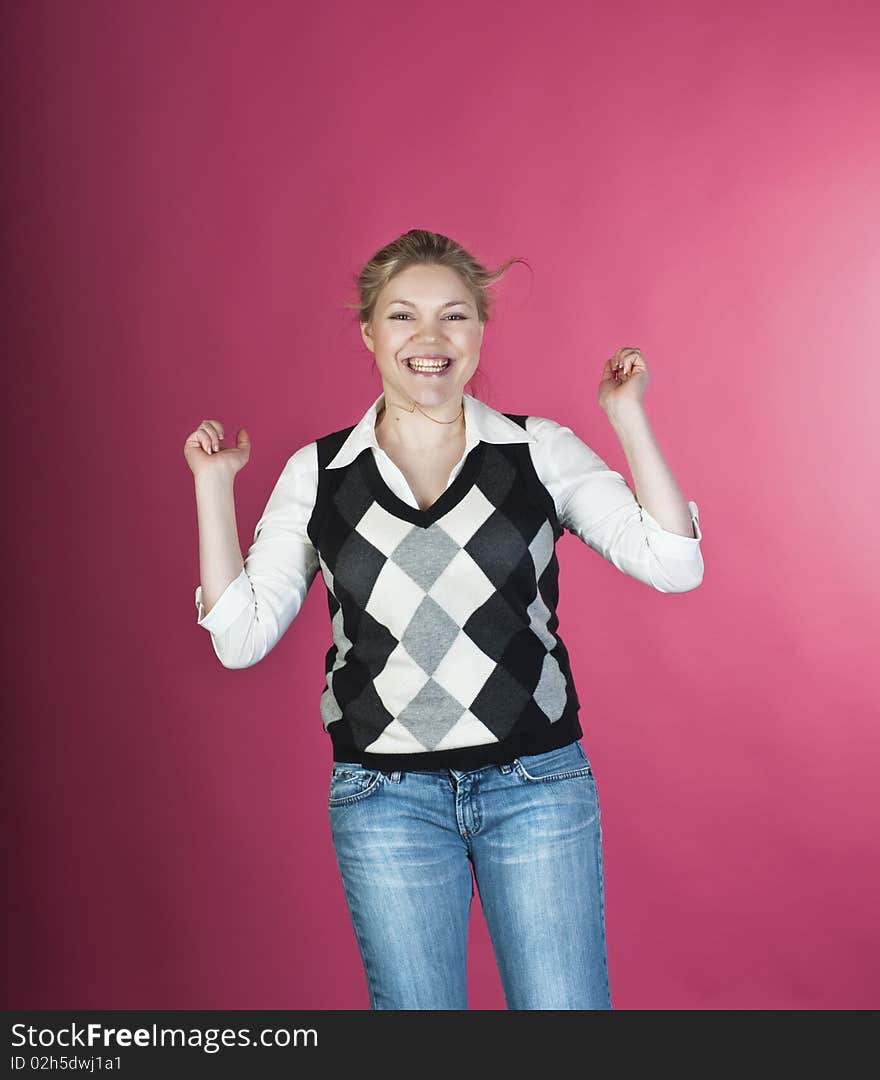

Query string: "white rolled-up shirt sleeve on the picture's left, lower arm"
[[195, 443, 320, 667]]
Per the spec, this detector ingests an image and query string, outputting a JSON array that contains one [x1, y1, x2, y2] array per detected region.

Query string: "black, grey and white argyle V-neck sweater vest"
[[308, 414, 582, 770]]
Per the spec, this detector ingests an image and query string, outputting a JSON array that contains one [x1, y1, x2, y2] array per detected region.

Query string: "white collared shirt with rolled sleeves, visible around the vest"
[[195, 393, 703, 667]]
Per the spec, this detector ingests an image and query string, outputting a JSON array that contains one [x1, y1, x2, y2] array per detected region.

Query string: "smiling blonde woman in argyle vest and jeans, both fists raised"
[[185, 230, 703, 1010]]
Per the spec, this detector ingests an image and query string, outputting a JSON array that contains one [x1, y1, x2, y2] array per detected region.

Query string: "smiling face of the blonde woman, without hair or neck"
[[361, 265, 484, 408]]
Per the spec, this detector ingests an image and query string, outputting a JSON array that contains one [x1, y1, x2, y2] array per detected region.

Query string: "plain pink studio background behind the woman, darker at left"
[[2, 0, 880, 1009]]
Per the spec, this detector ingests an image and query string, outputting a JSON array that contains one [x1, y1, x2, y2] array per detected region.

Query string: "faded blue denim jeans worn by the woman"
[[328, 741, 613, 1009]]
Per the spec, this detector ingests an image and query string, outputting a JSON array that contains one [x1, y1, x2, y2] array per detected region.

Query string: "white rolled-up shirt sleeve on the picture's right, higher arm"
[[527, 417, 704, 593]]
